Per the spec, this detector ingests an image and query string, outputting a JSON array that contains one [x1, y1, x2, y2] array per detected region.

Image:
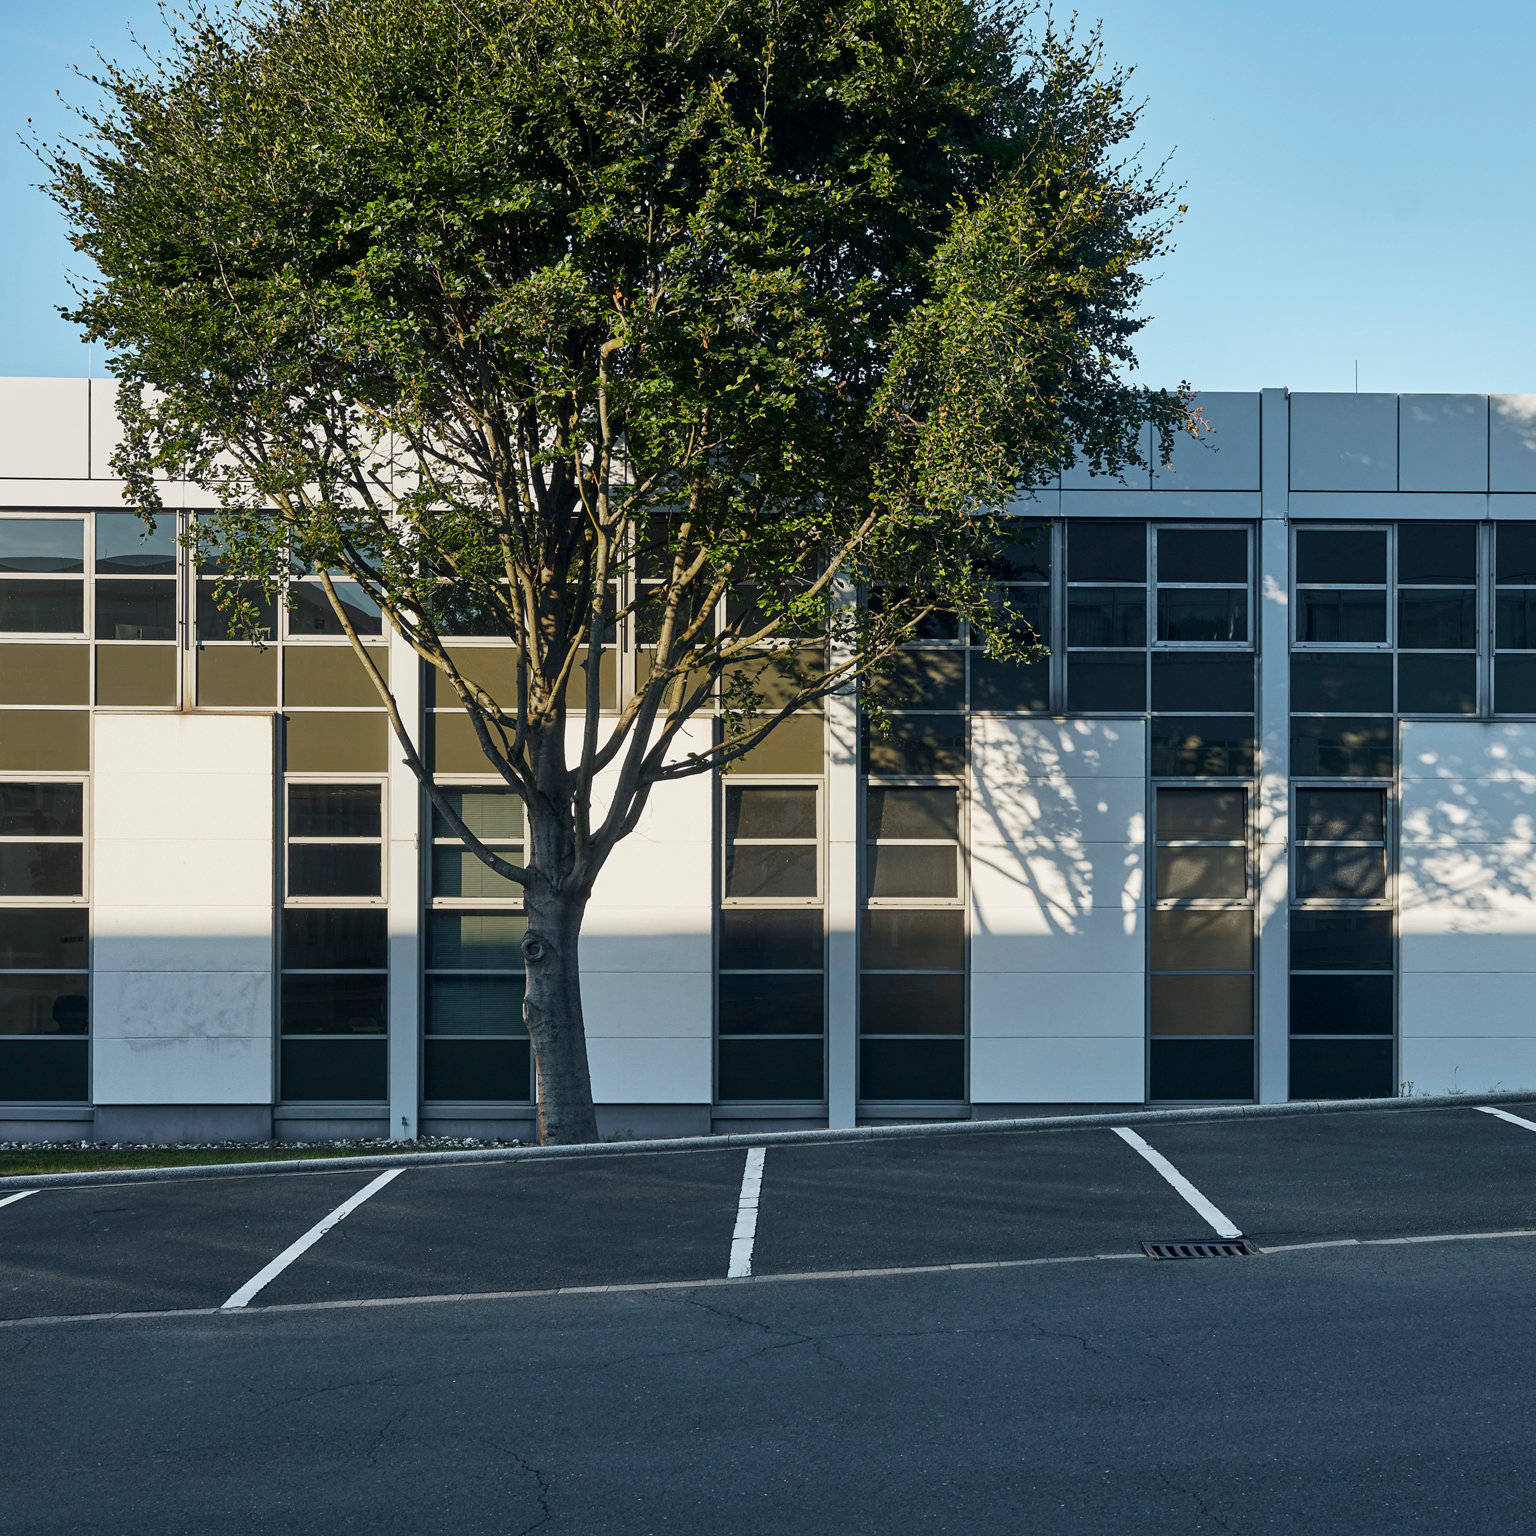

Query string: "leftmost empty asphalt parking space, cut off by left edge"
[[0, 1172, 382, 1318]]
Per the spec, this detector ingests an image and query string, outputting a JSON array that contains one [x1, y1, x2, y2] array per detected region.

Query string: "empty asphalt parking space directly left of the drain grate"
[[753, 1130, 1204, 1275]]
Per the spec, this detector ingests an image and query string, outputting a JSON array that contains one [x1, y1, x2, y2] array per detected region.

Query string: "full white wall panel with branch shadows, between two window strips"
[[971, 717, 1146, 1104]]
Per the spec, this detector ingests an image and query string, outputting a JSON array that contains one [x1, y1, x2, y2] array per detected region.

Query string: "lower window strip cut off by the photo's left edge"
[[0, 780, 91, 1103]]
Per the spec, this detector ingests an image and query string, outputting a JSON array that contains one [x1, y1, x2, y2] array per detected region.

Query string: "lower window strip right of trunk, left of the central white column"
[[716, 780, 826, 1104]]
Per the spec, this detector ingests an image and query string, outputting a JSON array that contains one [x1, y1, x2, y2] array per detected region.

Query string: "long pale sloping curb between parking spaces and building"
[[0, 1089, 1536, 1190]]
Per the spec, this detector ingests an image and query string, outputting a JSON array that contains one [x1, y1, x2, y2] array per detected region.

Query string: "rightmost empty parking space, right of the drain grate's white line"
[[1146, 1106, 1536, 1244]]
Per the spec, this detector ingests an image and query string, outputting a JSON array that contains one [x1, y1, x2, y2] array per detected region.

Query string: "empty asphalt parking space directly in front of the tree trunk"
[[251, 1147, 749, 1306]]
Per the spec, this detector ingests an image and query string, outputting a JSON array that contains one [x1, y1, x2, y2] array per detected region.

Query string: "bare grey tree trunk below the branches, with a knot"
[[522, 888, 598, 1146]]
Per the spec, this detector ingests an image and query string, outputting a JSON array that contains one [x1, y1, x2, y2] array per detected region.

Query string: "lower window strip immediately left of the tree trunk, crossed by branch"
[[422, 785, 535, 1104]]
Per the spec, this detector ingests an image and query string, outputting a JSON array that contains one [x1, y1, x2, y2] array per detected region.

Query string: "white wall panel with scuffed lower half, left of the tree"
[[91, 714, 273, 1104]]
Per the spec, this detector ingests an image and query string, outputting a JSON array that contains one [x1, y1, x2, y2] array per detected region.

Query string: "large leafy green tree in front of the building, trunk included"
[[40, 0, 1190, 1141]]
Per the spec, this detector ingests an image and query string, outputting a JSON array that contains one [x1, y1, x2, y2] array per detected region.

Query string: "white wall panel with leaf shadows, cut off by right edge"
[[1398, 720, 1536, 1094]]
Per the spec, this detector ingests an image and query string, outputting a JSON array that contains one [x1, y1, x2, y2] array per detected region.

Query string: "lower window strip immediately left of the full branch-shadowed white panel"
[[859, 783, 966, 1104]]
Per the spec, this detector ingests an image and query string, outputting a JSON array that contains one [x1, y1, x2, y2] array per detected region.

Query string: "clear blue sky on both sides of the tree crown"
[[0, 0, 1536, 392]]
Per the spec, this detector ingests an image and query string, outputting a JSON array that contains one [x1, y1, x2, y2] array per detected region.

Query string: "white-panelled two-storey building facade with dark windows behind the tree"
[[0, 379, 1536, 1140]]
